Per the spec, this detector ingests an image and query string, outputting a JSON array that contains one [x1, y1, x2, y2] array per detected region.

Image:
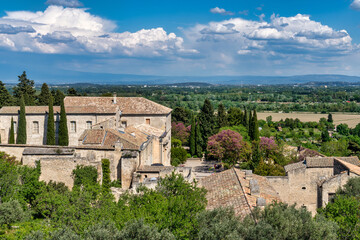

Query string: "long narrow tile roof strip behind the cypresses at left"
[[0, 105, 118, 114]]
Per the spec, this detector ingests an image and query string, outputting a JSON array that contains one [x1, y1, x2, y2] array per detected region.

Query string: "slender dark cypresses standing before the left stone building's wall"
[[8, 96, 69, 146]]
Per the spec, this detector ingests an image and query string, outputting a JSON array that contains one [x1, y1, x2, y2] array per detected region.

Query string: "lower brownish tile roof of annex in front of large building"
[[79, 129, 149, 150]]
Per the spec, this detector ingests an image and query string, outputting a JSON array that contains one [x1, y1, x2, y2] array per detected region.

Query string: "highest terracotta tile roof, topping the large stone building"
[[64, 97, 172, 114]]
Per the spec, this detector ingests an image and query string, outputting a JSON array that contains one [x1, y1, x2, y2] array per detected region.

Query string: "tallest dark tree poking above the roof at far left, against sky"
[[13, 71, 36, 106]]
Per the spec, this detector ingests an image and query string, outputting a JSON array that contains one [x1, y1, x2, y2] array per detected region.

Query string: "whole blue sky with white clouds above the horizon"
[[0, 0, 360, 82]]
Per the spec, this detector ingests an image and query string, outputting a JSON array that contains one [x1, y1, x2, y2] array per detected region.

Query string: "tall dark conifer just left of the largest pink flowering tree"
[[198, 99, 216, 149]]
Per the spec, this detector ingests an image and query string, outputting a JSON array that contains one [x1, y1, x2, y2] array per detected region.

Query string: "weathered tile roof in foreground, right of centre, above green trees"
[[199, 168, 280, 218]]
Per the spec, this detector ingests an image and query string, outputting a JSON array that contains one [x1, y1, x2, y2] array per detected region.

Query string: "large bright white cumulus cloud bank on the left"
[[0, 5, 196, 57]]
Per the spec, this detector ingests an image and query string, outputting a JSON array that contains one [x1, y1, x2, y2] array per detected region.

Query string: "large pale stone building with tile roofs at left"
[[0, 96, 172, 189]]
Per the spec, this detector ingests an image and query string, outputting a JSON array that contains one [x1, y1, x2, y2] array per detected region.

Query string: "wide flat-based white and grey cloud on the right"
[[186, 14, 358, 60]]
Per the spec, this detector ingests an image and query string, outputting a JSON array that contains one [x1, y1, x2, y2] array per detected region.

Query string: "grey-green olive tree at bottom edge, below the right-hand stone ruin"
[[242, 203, 338, 240]]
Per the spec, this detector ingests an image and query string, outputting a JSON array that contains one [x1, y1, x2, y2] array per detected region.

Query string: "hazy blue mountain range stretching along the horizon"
[[4, 73, 360, 86]]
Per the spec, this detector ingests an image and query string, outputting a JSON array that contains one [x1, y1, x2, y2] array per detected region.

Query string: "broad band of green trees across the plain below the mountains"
[[0, 72, 360, 113]]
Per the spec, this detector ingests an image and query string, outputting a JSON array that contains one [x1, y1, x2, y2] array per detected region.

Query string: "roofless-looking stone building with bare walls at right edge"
[[267, 157, 360, 214]]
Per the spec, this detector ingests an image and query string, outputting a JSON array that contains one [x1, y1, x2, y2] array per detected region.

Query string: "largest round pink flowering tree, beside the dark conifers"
[[207, 130, 251, 166]]
